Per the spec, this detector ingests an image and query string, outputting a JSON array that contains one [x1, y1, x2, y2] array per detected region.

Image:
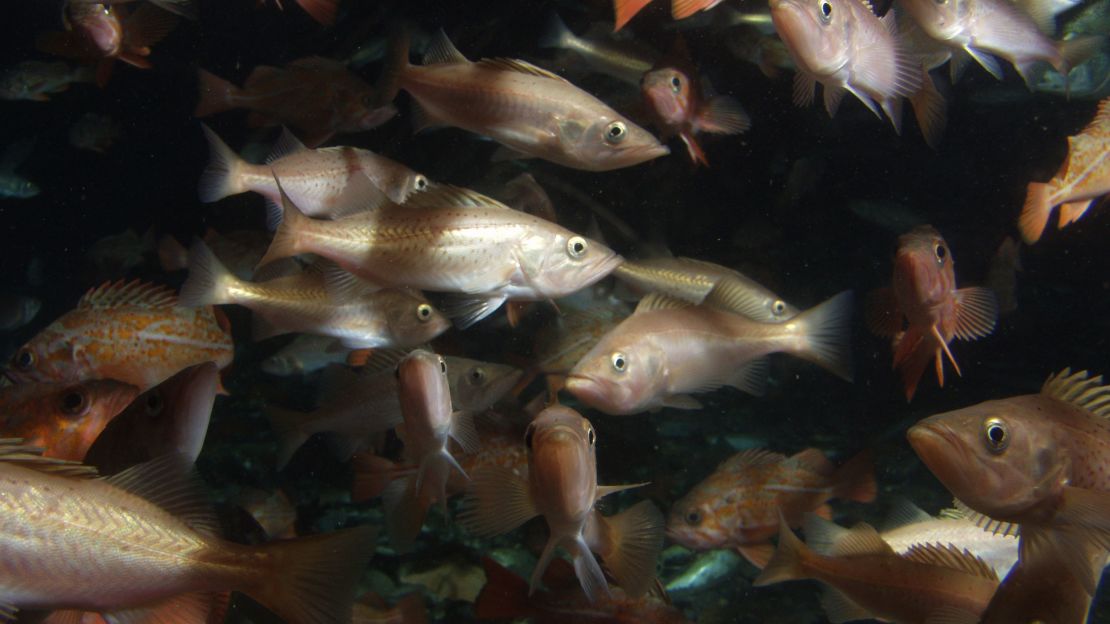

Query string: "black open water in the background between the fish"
[[0, 0, 1110, 622]]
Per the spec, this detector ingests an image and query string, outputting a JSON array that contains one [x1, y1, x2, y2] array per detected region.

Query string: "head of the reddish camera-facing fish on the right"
[[894, 225, 956, 305]]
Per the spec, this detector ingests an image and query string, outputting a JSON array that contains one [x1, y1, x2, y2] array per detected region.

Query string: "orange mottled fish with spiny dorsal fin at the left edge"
[[8, 280, 234, 392]]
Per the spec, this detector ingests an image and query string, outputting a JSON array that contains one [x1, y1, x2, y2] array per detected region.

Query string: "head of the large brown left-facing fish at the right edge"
[[907, 395, 1069, 522]]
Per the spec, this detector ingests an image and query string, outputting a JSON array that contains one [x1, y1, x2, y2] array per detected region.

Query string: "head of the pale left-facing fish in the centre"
[[566, 325, 666, 415]]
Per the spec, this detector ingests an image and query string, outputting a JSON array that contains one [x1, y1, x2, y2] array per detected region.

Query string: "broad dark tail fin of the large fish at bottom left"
[[245, 526, 377, 624]]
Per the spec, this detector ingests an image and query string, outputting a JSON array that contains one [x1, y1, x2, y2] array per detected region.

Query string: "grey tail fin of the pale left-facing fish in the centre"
[[790, 291, 852, 381]]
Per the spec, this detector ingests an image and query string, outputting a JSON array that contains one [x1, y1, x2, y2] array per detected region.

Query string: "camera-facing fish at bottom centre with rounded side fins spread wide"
[[458, 404, 663, 604]]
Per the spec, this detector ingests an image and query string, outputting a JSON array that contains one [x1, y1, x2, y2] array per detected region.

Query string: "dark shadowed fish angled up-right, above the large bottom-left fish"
[[83, 362, 220, 474]]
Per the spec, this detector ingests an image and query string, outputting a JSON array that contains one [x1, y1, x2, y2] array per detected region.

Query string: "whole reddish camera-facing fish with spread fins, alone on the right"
[[867, 225, 998, 402]]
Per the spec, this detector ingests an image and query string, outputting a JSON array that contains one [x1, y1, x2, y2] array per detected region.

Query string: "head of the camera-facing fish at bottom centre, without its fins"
[[524, 405, 597, 521]]
